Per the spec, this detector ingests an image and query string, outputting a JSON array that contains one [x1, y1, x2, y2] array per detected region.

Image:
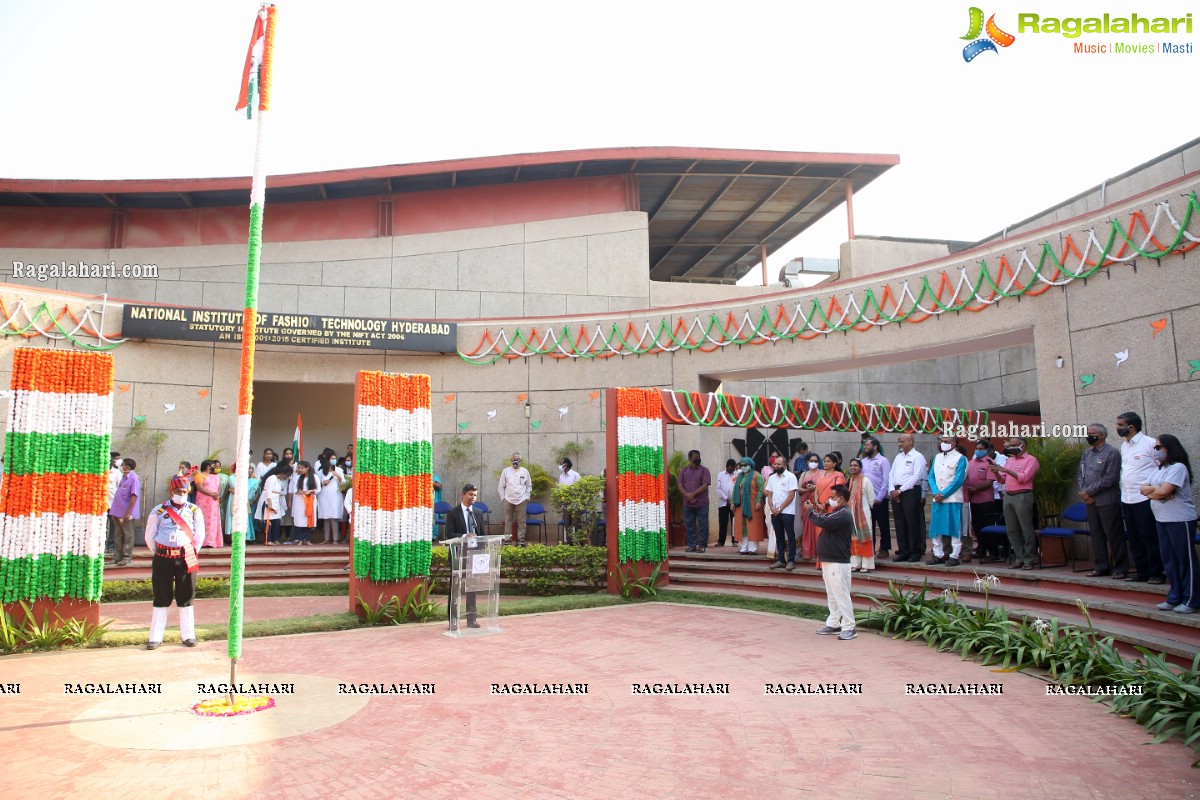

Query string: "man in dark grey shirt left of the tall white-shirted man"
[[1079, 422, 1129, 581]]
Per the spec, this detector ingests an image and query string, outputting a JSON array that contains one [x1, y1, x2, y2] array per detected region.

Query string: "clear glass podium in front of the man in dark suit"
[[445, 534, 504, 637]]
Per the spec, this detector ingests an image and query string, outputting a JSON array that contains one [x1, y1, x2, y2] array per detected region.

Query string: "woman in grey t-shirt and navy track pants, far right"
[[1140, 433, 1200, 614]]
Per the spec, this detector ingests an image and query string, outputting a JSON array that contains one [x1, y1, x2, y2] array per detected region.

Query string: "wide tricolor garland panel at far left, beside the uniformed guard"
[[0, 348, 113, 603]]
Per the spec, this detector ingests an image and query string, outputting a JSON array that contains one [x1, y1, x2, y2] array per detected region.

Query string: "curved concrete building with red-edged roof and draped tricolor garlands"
[[0, 140, 1200, 503]]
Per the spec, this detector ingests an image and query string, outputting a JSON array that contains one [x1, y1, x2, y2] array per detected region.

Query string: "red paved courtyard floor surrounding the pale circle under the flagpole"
[[0, 603, 1200, 800]]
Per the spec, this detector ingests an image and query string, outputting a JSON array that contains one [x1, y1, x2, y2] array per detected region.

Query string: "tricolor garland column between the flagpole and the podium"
[[354, 372, 433, 582]]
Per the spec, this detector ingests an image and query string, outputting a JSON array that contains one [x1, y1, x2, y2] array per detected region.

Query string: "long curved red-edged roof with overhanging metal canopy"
[[0, 148, 900, 283]]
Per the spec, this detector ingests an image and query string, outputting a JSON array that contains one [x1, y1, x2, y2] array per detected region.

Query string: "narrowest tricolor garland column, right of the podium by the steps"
[[617, 389, 667, 564]]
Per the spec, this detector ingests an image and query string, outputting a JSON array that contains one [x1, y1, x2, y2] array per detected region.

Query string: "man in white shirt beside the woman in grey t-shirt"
[[1117, 411, 1166, 584]]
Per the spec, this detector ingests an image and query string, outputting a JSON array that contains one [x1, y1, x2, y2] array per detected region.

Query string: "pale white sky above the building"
[[0, 0, 1200, 282]]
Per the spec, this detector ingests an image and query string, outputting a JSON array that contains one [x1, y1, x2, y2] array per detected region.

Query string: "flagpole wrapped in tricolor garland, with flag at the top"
[[228, 4, 275, 706]]
